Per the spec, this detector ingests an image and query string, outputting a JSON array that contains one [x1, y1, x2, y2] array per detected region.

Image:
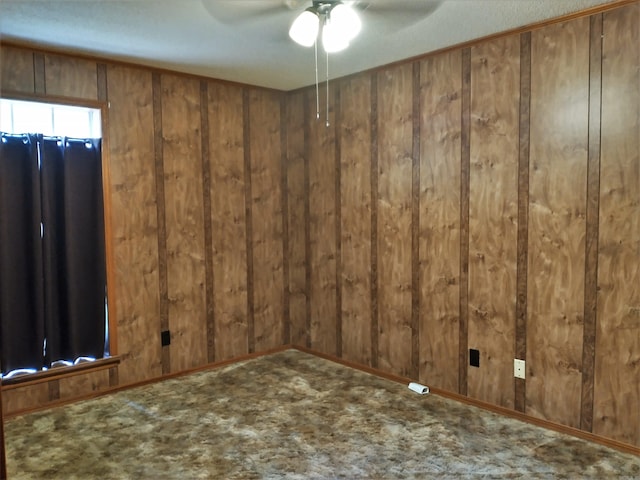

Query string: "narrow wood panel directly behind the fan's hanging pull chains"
[[306, 90, 337, 354]]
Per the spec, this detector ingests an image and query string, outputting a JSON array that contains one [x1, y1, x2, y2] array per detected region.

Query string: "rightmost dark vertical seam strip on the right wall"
[[580, 14, 603, 432]]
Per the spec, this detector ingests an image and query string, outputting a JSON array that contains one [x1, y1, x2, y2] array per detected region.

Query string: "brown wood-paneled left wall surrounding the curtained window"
[[0, 45, 284, 413]]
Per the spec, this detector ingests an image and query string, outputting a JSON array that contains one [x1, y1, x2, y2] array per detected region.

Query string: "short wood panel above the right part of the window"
[[44, 54, 98, 100]]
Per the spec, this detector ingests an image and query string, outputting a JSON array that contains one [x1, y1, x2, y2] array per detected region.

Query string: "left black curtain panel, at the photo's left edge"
[[0, 135, 44, 373]]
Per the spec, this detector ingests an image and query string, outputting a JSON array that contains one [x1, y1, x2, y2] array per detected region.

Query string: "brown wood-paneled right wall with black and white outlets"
[[288, 3, 640, 446]]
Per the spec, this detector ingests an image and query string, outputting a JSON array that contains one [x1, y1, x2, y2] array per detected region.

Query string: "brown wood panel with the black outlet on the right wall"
[[468, 35, 520, 408]]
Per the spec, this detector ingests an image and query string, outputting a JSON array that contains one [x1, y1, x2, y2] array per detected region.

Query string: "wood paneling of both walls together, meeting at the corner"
[[1, 2, 640, 452]]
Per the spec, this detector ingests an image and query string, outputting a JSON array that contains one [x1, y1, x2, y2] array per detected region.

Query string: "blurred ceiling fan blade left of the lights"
[[201, 0, 304, 25]]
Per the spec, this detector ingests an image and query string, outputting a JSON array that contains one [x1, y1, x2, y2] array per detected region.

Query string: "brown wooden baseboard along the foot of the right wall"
[[292, 345, 640, 456]]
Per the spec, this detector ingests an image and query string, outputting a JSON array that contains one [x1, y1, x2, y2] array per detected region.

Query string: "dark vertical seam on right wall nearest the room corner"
[[302, 92, 311, 348]]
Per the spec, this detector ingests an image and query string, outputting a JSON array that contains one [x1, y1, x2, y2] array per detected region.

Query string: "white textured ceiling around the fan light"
[[0, 0, 615, 90]]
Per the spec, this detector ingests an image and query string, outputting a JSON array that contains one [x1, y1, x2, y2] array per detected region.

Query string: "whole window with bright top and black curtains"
[[0, 99, 109, 378]]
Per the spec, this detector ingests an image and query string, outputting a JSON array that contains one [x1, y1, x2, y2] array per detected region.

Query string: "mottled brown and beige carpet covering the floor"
[[5, 350, 640, 480]]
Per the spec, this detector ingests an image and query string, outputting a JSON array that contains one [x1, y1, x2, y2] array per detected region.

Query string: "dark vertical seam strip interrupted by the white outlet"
[[514, 32, 531, 412]]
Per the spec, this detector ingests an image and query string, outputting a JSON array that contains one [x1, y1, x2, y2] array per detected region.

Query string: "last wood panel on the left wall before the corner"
[[249, 89, 284, 351]]
